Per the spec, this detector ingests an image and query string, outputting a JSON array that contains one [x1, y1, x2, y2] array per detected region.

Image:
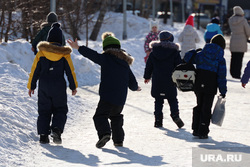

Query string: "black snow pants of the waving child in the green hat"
[[93, 100, 125, 143]]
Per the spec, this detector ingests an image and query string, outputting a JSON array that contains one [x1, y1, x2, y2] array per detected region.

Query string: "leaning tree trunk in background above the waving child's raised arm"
[[89, 0, 107, 41]]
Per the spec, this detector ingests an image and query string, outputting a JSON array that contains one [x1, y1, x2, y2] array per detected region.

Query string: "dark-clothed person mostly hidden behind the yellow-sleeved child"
[[31, 12, 65, 55]]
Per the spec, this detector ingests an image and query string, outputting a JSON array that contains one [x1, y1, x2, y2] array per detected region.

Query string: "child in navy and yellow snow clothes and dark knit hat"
[[27, 23, 78, 144]]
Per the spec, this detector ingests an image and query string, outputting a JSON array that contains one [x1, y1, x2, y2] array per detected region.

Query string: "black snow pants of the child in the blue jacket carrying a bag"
[[192, 92, 214, 136]]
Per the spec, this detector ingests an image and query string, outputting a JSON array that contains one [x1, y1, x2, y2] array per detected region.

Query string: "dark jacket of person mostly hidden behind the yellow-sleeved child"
[[32, 23, 65, 54]]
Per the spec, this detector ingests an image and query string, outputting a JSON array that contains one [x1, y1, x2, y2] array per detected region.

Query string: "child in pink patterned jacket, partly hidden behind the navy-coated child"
[[144, 21, 160, 63]]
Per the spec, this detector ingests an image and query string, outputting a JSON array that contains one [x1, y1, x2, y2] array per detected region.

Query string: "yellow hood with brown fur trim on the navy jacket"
[[37, 41, 72, 61]]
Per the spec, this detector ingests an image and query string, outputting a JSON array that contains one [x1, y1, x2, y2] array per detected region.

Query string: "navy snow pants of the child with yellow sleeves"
[[37, 90, 68, 135]]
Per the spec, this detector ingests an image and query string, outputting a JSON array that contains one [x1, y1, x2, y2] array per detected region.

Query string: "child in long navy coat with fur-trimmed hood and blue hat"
[[144, 31, 184, 128]]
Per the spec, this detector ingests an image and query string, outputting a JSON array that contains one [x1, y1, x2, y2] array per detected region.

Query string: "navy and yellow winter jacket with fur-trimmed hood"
[[27, 41, 78, 97]]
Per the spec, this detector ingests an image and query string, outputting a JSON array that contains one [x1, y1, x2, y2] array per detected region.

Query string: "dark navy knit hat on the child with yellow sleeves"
[[47, 23, 63, 45]]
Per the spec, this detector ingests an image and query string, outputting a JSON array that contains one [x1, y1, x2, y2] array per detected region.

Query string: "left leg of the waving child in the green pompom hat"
[[93, 100, 111, 139]]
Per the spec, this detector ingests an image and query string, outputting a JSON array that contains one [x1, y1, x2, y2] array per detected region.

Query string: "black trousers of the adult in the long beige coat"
[[230, 52, 244, 79]]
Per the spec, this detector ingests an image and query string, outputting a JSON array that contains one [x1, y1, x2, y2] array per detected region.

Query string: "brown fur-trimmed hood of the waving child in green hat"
[[103, 48, 134, 65]]
